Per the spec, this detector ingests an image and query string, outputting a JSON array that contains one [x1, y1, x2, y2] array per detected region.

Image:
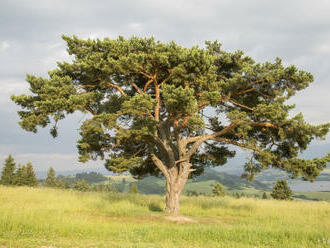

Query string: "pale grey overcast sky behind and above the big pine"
[[0, 0, 330, 170]]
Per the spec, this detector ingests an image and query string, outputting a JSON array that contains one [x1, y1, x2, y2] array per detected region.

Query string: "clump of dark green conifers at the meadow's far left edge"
[[1, 155, 38, 187]]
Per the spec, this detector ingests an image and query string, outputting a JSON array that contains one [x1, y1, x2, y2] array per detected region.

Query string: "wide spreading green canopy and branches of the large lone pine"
[[12, 36, 330, 213]]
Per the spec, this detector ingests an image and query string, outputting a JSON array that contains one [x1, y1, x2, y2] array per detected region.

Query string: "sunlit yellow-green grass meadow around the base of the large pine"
[[0, 187, 330, 248]]
